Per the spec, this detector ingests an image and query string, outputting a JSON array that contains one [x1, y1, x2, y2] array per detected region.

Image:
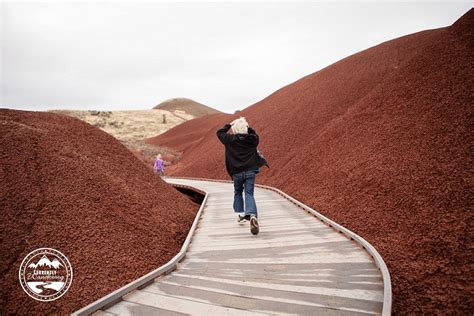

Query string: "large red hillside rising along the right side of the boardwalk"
[[148, 10, 474, 314]]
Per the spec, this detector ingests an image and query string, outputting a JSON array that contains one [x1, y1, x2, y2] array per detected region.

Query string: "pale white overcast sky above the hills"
[[0, 1, 474, 113]]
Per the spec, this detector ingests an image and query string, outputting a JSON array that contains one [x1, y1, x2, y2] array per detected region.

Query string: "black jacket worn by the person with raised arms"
[[217, 124, 259, 177]]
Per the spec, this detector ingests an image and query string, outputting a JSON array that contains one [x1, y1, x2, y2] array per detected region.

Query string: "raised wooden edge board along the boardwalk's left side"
[[71, 184, 208, 316]]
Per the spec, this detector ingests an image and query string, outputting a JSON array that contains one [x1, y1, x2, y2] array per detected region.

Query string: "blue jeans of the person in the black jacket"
[[232, 170, 258, 216]]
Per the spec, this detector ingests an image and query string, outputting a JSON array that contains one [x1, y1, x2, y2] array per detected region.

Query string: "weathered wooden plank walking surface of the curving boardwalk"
[[102, 179, 384, 315]]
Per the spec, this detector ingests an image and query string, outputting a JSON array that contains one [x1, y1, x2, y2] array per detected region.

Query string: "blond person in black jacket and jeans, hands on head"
[[217, 117, 260, 235]]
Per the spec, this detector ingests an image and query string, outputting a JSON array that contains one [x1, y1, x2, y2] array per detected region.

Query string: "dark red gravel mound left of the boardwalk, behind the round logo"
[[0, 110, 198, 315]]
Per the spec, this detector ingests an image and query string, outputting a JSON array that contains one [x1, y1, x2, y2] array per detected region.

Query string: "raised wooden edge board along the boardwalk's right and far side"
[[165, 177, 392, 316]]
